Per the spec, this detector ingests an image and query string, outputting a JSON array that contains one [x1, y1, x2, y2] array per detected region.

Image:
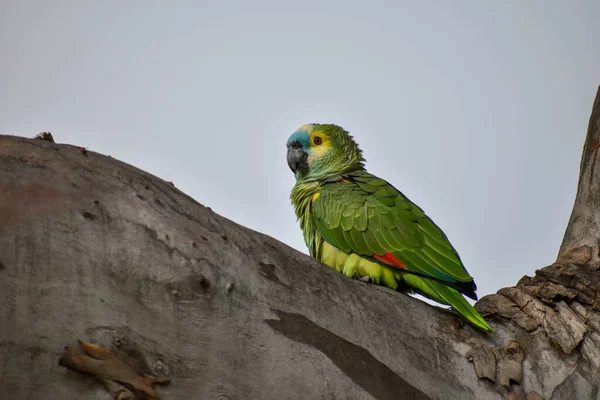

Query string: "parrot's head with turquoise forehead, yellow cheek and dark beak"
[[287, 124, 365, 181]]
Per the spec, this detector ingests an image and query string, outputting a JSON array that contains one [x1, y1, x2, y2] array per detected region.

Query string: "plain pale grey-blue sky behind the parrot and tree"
[[0, 0, 600, 296]]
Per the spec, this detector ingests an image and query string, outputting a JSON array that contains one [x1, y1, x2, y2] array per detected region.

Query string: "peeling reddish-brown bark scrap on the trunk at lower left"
[[58, 340, 169, 400]]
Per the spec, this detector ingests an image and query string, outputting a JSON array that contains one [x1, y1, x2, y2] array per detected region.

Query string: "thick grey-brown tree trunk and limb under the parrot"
[[0, 88, 600, 400]]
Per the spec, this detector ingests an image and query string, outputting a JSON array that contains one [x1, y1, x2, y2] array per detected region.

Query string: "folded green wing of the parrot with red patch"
[[313, 171, 477, 300]]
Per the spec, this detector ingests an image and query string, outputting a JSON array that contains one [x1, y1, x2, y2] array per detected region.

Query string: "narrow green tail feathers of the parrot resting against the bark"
[[402, 274, 494, 333]]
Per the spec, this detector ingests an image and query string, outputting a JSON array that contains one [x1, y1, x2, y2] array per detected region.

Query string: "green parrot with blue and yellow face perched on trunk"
[[287, 124, 493, 333]]
